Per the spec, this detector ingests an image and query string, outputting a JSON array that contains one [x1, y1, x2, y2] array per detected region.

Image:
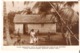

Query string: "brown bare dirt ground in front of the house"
[[3, 33, 79, 46]]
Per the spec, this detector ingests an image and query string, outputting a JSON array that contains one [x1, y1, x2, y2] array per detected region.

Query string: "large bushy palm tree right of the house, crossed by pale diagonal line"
[[50, 2, 78, 44]]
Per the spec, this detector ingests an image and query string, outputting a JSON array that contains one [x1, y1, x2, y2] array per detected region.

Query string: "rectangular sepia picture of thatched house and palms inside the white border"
[[3, 1, 79, 46]]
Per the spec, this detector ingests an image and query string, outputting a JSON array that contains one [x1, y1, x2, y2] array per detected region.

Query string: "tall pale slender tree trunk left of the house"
[[4, 2, 11, 45]]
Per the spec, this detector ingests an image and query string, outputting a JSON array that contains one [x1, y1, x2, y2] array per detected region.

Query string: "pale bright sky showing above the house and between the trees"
[[6, 1, 79, 13]]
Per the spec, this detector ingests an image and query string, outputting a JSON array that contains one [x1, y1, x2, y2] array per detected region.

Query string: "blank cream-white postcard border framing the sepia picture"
[[0, 0, 80, 53]]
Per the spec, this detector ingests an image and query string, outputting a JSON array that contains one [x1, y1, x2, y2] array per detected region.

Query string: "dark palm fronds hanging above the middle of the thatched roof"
[[33, 2, 61, 17]]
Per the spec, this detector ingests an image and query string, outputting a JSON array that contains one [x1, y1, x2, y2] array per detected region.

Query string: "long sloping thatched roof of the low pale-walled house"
[[14, 14, 55, 24]]
